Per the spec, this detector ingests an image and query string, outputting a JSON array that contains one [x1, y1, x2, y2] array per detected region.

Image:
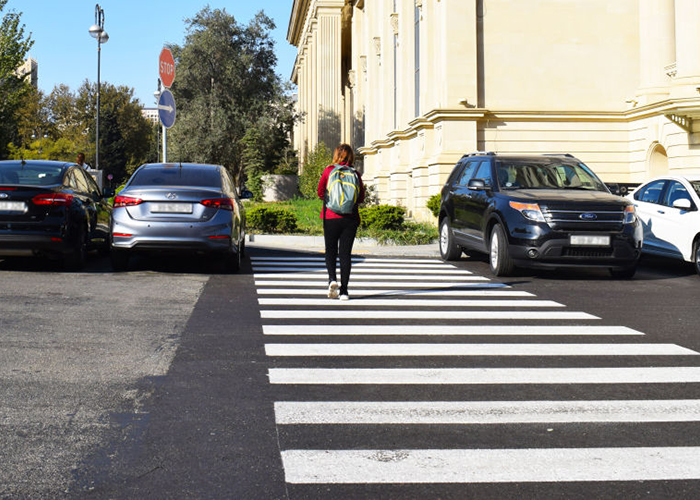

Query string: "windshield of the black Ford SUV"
[[496, 158, 607, 192]]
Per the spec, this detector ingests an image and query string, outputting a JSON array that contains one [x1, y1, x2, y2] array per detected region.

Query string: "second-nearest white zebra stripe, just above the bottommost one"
[[275, 399, 700, 425]]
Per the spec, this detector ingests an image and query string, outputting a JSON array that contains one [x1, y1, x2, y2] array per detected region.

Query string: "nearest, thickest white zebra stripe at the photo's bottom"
[[282, 446, 700, 484]]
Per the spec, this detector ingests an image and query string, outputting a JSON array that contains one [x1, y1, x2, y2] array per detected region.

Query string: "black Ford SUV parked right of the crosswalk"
[[439, 153, 642, 278]]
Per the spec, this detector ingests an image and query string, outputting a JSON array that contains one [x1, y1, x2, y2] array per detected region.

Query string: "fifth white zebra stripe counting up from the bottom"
[[263, 325, 644, 336]]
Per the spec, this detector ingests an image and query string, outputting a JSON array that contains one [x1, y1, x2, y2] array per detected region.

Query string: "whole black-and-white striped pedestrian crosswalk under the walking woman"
[[251, 256, 700, 491]]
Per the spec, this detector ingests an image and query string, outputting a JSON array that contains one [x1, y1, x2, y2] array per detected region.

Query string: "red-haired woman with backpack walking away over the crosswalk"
[[318, 144, 365, 300]]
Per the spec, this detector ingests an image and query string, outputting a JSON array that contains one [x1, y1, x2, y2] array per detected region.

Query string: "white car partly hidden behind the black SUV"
[[627, 175, 700, 274]]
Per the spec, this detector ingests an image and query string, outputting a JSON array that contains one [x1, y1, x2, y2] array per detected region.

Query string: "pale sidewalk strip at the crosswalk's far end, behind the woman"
[[246, 234, 440, 258]]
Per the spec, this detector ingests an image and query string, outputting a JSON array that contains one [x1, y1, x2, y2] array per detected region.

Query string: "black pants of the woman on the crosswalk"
[[323, 217, 359, 294]]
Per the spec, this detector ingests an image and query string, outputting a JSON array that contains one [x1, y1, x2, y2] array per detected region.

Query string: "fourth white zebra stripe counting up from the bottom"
[[265, 344, 698, 357]]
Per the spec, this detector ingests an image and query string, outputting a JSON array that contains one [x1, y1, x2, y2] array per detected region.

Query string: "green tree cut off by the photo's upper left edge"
[[0, 0, 34, 158]]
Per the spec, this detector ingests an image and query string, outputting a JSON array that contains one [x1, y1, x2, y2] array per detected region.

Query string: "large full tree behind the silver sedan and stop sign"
[[169, 7, 294, 186]]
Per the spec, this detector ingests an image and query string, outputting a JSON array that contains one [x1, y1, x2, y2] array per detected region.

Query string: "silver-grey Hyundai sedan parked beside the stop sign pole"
[[110, 163, 245, 272]]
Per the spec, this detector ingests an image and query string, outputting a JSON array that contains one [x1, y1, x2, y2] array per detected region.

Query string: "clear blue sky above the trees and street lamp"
[[3, 0, 296, 107]]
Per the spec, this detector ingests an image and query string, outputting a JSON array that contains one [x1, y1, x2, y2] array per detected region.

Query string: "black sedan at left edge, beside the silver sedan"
[[0, 160, 112, 270]]
